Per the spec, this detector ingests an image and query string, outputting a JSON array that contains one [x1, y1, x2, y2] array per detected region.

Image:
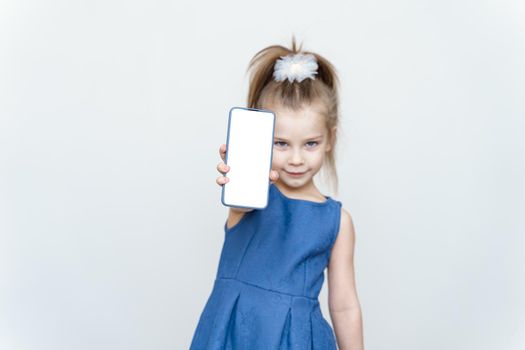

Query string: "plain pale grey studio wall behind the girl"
[[0, 0, 525, 350]]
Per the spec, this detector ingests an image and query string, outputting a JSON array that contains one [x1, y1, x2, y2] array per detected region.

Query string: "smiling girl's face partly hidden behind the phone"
[[267, 104, 331, 188]]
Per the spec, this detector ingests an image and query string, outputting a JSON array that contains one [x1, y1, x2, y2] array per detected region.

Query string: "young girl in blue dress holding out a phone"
[[190, 39, 364, 350]]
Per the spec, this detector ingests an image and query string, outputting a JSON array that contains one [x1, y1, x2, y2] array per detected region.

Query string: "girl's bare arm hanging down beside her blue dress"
[[328, 208, 364, 350]]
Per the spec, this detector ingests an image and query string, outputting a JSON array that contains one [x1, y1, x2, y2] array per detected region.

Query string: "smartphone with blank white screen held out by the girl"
[[221, 107, 275, 209]]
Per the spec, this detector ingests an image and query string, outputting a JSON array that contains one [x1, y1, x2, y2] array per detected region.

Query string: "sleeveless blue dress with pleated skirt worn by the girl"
[[190, 183, 341, 350]]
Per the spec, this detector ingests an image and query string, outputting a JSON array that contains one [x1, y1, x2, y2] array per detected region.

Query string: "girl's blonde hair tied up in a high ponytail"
[[248, 36, 339, 193]]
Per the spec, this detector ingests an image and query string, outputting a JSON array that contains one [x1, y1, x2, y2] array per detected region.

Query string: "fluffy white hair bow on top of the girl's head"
[[273, 53, 318, 83]]
